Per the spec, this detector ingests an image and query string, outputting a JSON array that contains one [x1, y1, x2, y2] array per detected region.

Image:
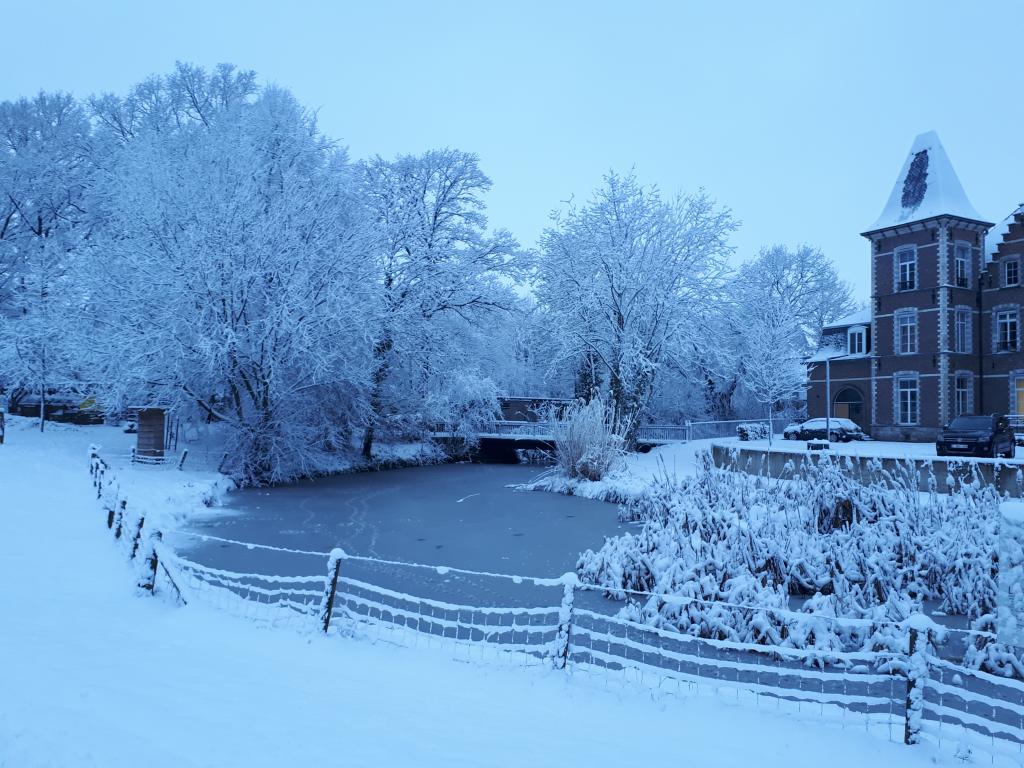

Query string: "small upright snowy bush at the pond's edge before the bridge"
[[549, 399, 623, 480]]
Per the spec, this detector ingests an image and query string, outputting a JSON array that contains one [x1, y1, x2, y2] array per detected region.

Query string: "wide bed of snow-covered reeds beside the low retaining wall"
[[577, 457, 998, 667]]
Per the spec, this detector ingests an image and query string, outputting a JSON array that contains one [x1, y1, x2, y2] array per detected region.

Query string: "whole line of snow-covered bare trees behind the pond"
[[0, 63, 852, 482]]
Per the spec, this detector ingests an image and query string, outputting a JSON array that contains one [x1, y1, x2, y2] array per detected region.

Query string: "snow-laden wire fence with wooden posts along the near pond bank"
[[90, 451, 1024, 766]]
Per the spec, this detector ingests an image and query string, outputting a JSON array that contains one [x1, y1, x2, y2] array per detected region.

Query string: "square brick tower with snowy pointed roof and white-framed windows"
[[862, 132, 991, 440]]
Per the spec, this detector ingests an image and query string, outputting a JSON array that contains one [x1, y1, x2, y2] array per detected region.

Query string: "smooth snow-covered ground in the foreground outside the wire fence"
[[0, 427, 955, 768]]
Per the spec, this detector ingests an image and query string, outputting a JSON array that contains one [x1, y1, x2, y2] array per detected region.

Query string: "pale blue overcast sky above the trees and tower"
[[0, 0, 1024, 299]]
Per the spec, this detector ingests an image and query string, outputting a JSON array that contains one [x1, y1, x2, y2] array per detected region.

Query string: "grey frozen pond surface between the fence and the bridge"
[[173, 464, 635, 605]]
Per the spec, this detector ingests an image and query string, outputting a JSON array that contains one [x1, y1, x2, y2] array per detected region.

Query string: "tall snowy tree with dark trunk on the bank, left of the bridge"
[[361, 150, 518, 459]]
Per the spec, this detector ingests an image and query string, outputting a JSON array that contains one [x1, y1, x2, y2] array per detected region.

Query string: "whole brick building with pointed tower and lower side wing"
[[808, 133, 1024, 440]]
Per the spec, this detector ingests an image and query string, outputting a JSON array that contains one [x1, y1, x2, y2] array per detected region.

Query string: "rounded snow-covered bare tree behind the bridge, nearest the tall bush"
[[538, 173, 736, 447]]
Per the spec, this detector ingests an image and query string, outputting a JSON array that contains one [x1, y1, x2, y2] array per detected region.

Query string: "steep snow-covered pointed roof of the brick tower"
[[868, 131, 984, 231]]
